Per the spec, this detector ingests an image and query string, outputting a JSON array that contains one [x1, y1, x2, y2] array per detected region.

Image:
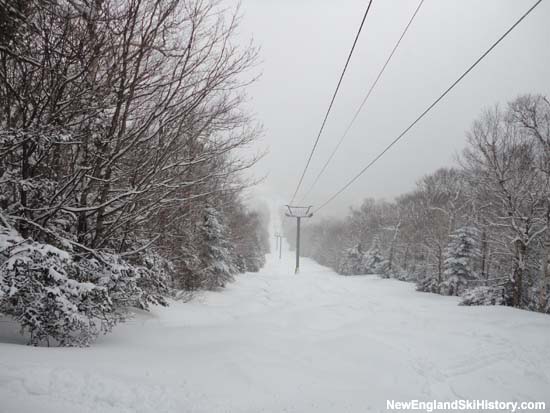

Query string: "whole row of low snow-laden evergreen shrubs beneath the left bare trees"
[[0, 230, 167, 346]]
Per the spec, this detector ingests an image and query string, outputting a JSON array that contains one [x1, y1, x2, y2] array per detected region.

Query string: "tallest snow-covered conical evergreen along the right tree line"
[[441, 227, 480, 295]]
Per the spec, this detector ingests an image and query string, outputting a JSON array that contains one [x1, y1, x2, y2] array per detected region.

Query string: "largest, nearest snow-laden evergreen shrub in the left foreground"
[[0, 232, 118, 346]]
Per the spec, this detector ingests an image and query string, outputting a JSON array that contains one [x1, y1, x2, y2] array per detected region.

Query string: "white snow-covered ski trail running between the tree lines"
[[0, 225, 550, 413]]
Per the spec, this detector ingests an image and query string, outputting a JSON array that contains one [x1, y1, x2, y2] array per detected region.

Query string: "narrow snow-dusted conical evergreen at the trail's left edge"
[[198, 207, 237, 290]]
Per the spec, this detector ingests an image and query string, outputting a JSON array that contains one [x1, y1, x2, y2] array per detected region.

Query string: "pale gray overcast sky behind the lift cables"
[[235, 0, 550, 214]]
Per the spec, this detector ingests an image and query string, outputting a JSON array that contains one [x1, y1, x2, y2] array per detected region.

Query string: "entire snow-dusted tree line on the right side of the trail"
[[286, 95, 550, 312]]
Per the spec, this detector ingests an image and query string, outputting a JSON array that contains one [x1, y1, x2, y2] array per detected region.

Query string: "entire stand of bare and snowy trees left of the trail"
[[0, 0, 269, 345]]
